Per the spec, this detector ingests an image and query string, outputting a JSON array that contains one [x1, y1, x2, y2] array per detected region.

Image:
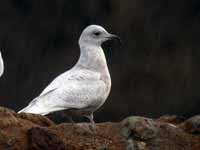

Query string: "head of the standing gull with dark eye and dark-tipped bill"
[[79, 25, 120, 46]]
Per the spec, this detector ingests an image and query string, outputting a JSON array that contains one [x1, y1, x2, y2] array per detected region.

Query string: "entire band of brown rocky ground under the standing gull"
[[0, 107, 200, 150]]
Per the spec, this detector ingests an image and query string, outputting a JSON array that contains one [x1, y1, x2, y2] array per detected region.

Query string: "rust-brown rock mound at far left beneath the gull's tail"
[[0, 107, 52, 150]]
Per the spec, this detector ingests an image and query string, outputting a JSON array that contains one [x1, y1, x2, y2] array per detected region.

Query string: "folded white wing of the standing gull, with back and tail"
[[19, 71, 105, 115]]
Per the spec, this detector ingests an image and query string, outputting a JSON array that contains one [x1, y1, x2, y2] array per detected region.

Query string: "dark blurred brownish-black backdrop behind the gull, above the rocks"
[[0, 0, 200, 122]]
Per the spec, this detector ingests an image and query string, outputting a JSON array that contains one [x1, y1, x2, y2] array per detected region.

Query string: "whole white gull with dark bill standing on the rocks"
[[19, 25, 119, 129]]
